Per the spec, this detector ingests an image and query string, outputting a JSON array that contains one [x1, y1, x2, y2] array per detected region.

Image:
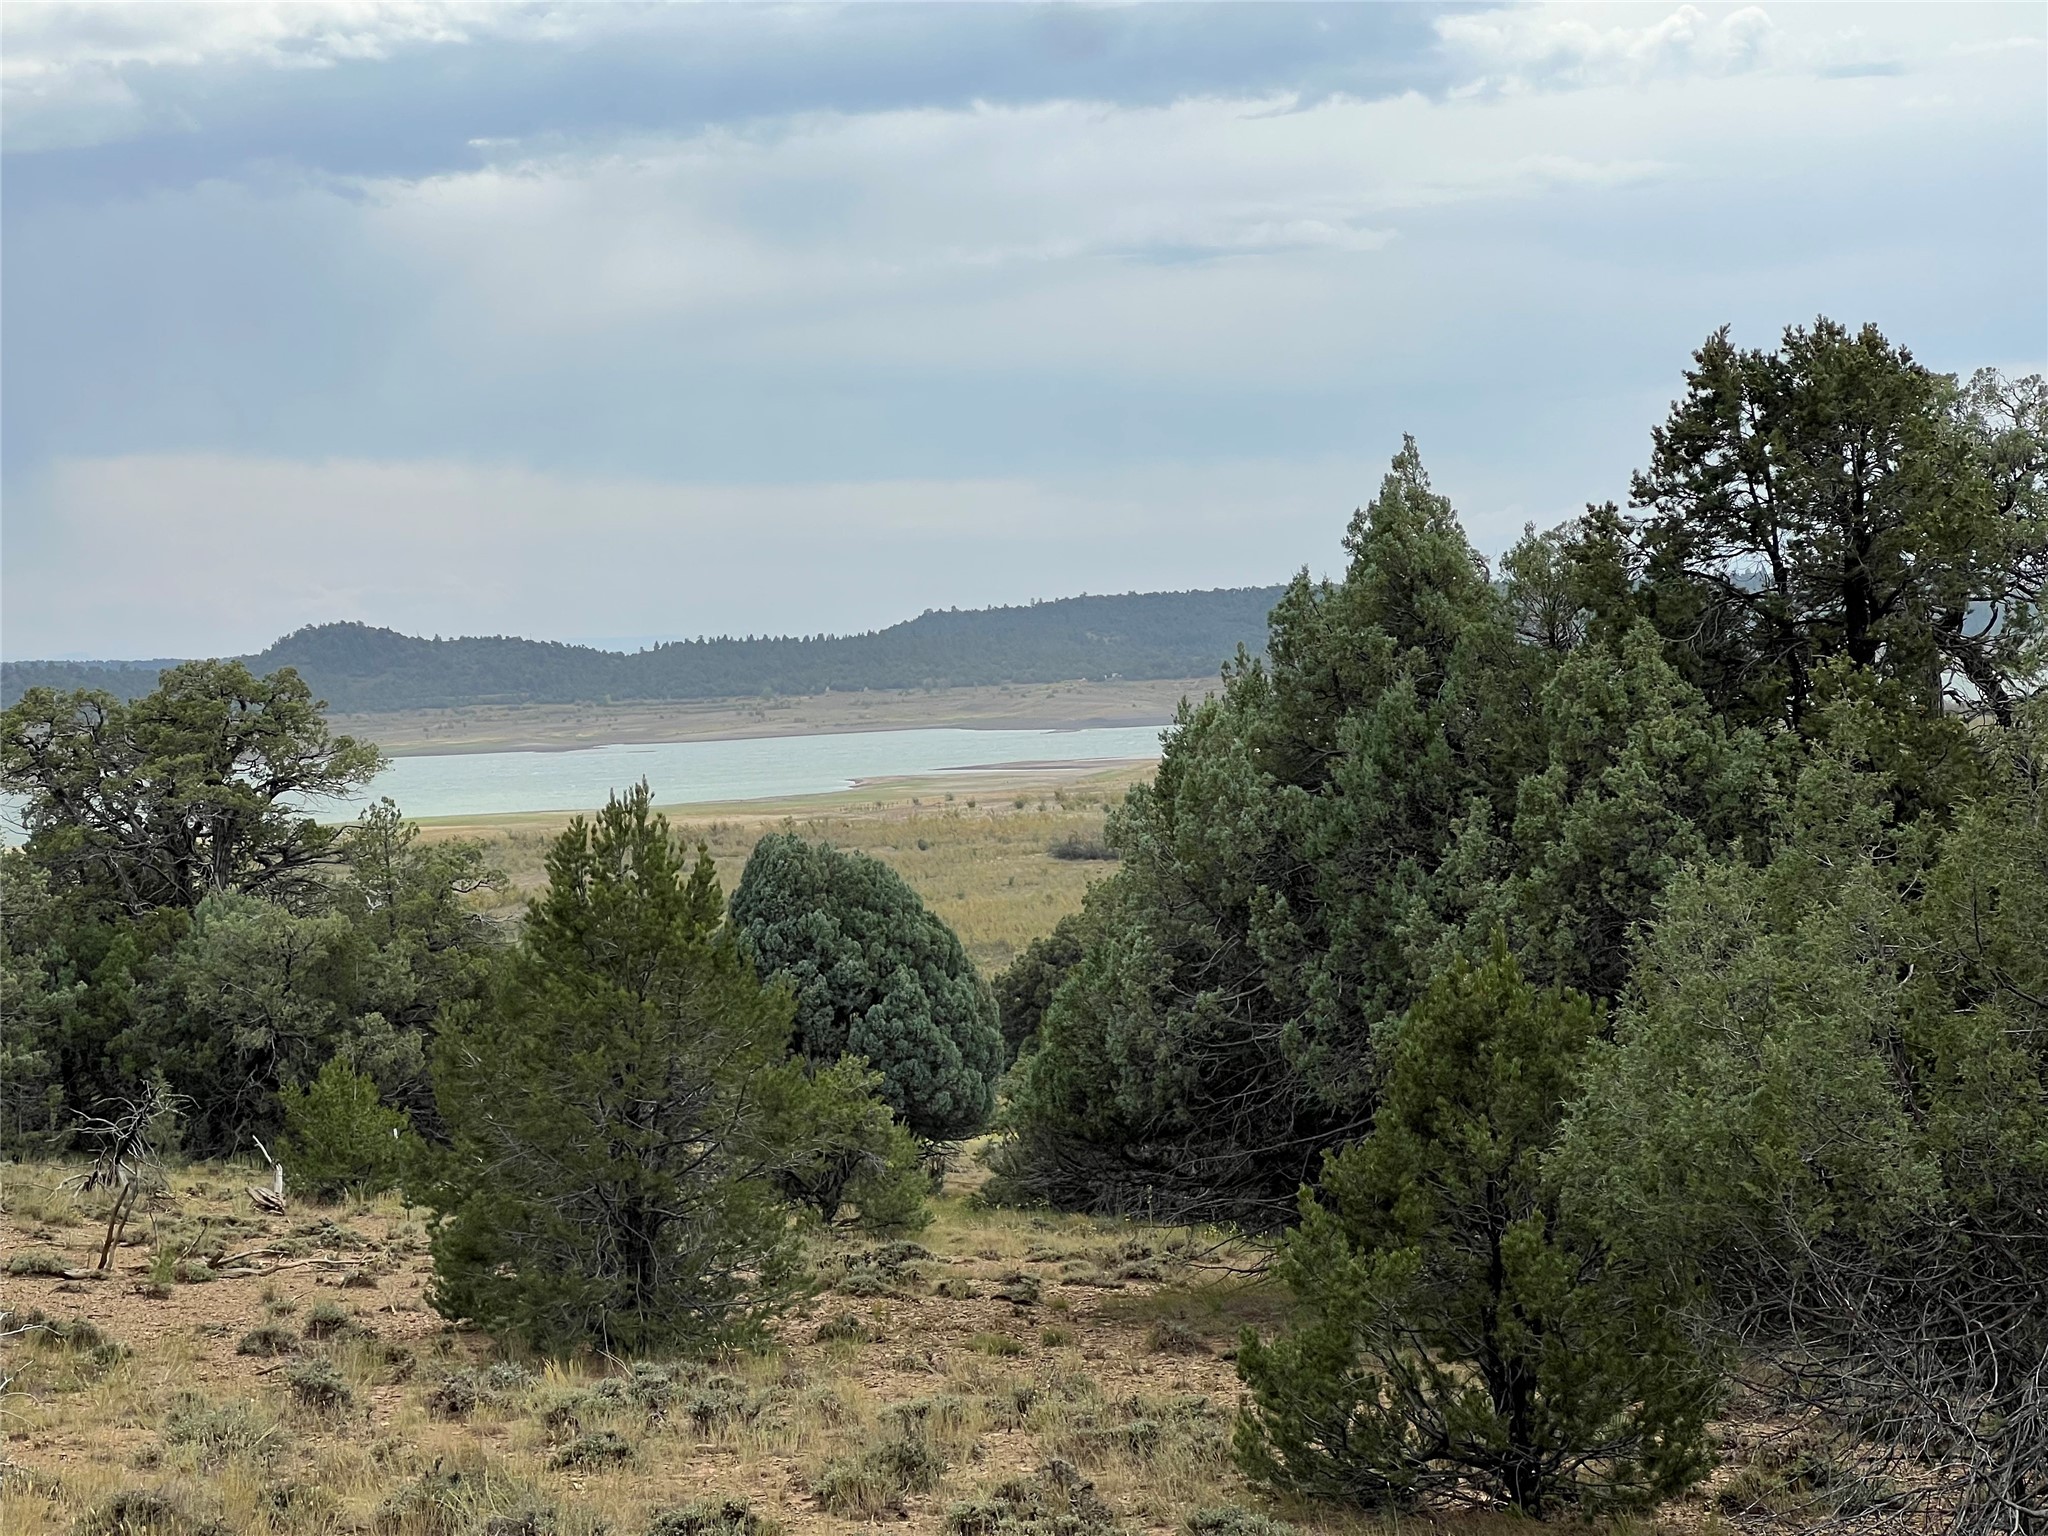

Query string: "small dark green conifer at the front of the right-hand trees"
[[1237, 938, 1718, 1516]]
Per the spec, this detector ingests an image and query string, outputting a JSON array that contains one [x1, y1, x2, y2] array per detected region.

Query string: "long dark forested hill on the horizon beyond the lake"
[[0, 586, 1280, 713]]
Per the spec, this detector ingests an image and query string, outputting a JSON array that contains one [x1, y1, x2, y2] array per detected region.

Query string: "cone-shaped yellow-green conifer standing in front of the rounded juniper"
[[418, 784, 844, 1354]]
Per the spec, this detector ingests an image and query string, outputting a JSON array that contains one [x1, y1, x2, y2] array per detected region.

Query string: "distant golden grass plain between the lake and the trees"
[[424, 766, 1151, 973]]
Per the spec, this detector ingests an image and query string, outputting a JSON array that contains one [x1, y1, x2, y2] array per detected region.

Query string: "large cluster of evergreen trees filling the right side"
[[993, 319, 2048, 1532]]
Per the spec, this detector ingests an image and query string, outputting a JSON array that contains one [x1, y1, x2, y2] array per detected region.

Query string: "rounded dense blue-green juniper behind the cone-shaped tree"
[[733, 834, 1004, 1141]]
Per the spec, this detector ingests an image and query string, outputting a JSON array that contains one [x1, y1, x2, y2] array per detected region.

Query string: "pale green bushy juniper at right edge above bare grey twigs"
[[1559, 733, 2048, 1530]]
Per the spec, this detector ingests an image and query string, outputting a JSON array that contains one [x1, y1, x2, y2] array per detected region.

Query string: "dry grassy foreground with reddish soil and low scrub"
[[0, 1165, 1736, 1536]]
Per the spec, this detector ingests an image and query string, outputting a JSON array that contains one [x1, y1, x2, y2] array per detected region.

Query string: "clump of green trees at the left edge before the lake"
[[0, 662, 500, 1155]]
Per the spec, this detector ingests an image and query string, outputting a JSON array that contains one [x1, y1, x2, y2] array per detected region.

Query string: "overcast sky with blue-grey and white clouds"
[[0, 0, 2048, 657]]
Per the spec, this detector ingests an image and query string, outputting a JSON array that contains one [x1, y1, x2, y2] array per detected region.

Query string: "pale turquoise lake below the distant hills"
[[322, 725, 1161, 819]]
